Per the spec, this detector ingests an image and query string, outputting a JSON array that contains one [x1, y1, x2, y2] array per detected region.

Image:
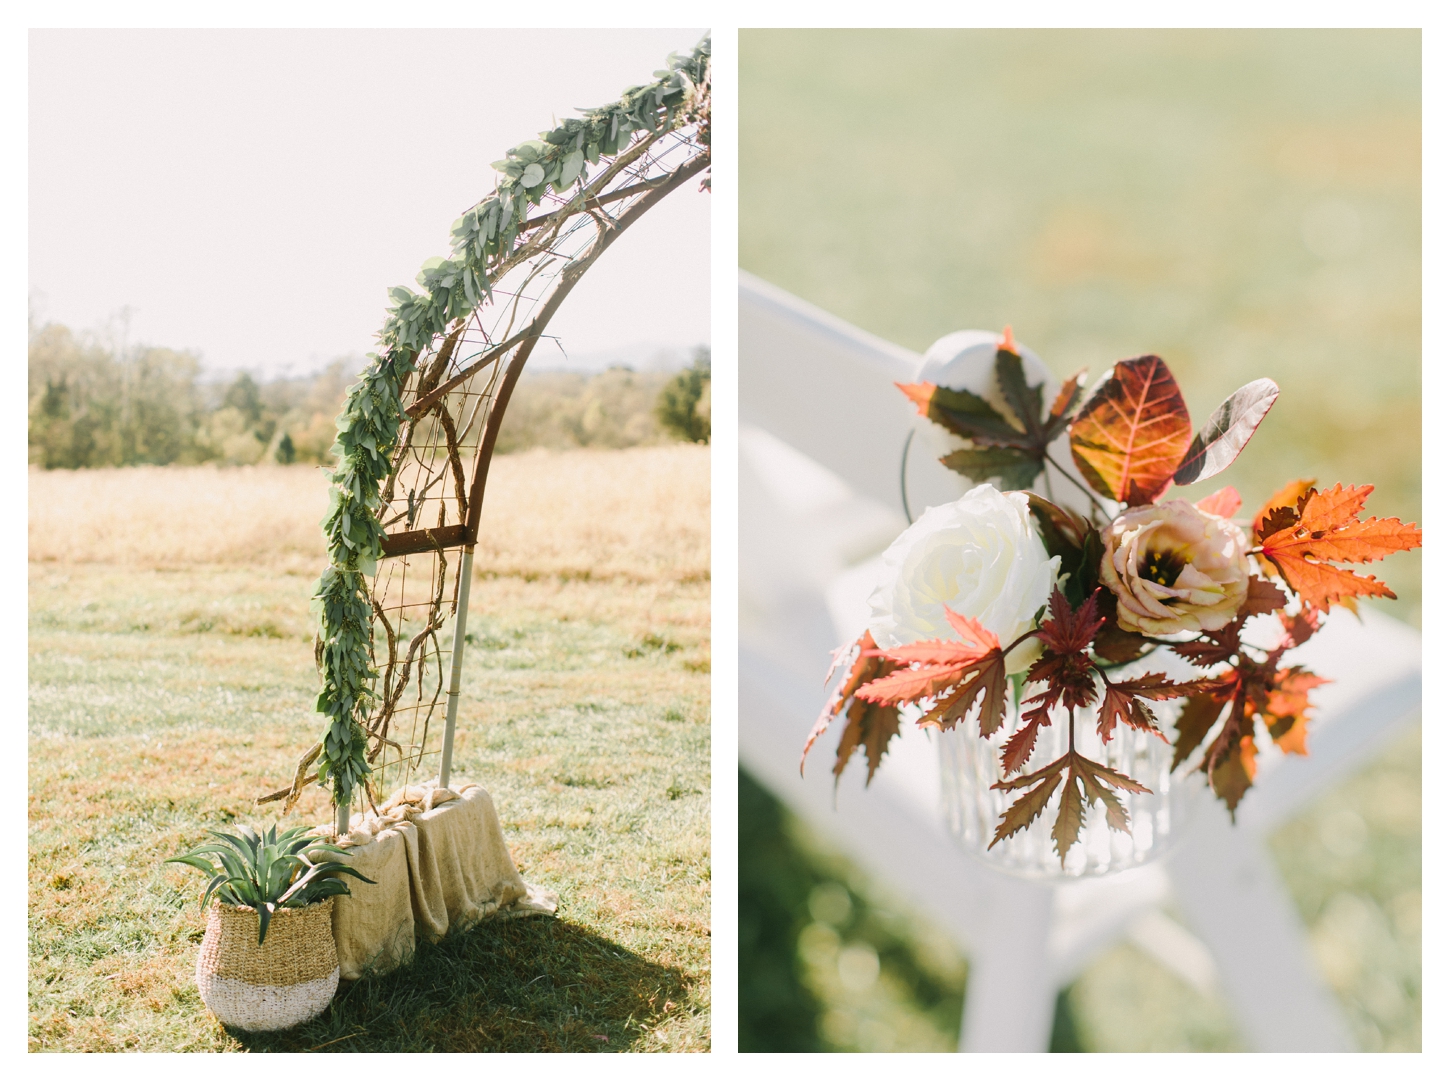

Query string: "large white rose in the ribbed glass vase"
[[869, 484, 1059, 672]]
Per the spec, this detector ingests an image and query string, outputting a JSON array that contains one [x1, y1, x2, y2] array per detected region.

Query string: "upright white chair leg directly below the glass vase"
[[960, 877, 1057, 1052]]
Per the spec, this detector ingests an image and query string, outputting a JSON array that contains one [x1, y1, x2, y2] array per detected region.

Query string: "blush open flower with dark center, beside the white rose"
[[1102, 500, 1250, 635]]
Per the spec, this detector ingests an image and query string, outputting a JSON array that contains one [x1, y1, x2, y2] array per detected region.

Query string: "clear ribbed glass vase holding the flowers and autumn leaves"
[[934, 649, 1189, 878]]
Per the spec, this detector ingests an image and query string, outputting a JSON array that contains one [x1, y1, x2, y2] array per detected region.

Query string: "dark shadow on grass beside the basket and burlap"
[[232, 919, 689, 1052]]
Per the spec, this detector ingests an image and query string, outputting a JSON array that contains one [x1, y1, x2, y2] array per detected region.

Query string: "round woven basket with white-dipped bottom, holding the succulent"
[[196, 897, 339, 1032]]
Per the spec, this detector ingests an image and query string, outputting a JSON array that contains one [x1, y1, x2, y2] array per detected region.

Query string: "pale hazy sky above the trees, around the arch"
[[29, 29, 711, 374]]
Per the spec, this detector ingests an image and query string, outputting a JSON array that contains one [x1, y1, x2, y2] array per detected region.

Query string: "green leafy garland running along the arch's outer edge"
[[313, 35, 711, 807]]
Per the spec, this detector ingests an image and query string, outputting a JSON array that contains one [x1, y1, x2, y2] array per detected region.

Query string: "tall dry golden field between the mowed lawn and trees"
[[29, 445, 709, 581]]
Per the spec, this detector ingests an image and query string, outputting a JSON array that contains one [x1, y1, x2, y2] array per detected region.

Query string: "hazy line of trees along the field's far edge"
[[28, 323, 709, 469]]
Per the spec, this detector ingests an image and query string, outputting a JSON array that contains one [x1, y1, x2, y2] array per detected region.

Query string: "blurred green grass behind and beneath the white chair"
[[740, 30, 1421, 1051]]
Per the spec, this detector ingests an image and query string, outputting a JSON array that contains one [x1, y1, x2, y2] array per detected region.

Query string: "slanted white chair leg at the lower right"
[[1169, 806, 1354, 1051]]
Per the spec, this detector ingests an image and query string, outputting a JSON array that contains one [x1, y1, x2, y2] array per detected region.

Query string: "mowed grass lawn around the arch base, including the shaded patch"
[[29, 448, 711, 1052]]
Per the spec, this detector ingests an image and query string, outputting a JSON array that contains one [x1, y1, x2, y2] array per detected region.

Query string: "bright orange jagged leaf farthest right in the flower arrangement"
[[1260, 484, 1421, 610]]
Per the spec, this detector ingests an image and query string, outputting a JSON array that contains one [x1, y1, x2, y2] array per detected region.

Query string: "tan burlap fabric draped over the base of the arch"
[[332, 781, 558, 980]]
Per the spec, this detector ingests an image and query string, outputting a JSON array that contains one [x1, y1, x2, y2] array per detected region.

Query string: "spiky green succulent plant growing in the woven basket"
[[165, 826, 374, 945]]
